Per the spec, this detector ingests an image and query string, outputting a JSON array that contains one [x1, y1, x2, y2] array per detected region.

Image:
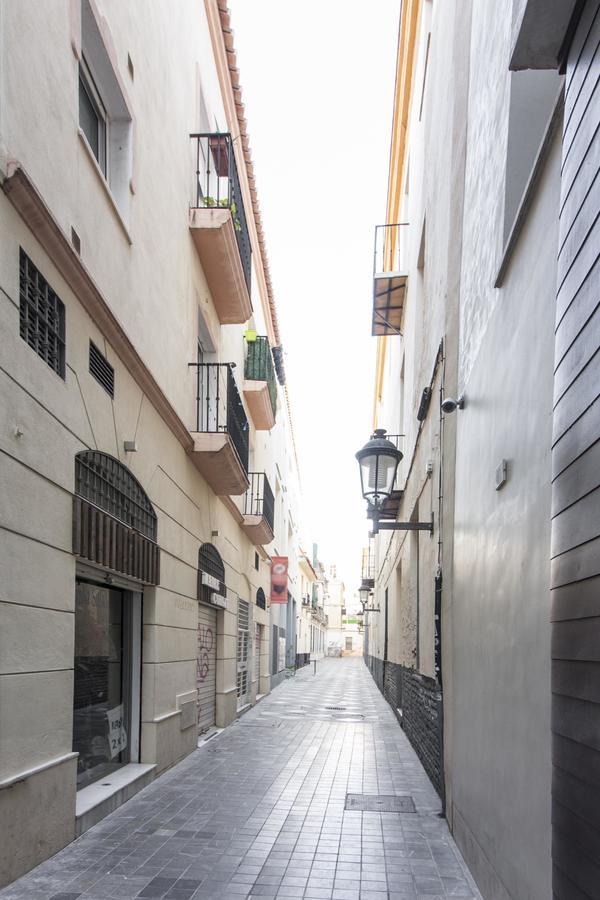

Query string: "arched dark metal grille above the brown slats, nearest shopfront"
[[75, 450, 157, 541]]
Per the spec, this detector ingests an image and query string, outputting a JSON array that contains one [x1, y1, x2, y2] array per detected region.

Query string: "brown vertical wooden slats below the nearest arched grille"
[[73, 495, 160, 584]]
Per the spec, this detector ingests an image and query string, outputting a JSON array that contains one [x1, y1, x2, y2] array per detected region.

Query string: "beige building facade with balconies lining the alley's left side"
[[0, 0, 299, 884]]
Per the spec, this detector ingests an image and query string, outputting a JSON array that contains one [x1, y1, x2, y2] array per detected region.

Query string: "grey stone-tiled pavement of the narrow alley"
[[0, 658, 480, 900]]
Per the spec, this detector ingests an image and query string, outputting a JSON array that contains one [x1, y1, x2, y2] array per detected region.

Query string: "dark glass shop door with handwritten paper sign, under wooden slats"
[[73, 580, 141, 788]]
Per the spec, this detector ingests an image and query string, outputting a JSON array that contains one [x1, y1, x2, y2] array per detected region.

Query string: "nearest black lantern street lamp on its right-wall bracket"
[[356, 428, 433, 534]]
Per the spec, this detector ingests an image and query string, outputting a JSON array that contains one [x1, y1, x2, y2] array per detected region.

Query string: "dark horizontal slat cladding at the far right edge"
[[552, 0, 600, 900]]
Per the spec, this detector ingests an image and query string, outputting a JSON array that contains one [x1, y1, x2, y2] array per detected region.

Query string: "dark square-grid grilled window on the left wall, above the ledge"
[[19, 248, 65, 378]]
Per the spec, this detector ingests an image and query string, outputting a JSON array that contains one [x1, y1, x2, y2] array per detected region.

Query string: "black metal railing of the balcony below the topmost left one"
[[190, 363, 249, 472]]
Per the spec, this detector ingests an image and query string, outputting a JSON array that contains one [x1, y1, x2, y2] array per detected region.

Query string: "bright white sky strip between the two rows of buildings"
[[229, 0, 400, 599]]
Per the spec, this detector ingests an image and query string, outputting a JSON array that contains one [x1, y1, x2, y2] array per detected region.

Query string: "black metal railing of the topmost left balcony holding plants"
[[190, 131, 252, 291]]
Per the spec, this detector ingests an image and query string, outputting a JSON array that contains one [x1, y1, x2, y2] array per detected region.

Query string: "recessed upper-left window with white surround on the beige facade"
[[79, 0, 133, 219]]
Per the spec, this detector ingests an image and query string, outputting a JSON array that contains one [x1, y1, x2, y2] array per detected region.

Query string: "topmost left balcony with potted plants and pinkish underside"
[[190, 132, 252, 325]]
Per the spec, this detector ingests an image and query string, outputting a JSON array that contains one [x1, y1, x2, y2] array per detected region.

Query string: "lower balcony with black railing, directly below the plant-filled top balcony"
[[190, 363, 250, 496]]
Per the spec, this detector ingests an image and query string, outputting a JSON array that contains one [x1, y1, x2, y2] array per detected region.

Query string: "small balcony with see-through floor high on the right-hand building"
[[371, 222, 408, 337]]
